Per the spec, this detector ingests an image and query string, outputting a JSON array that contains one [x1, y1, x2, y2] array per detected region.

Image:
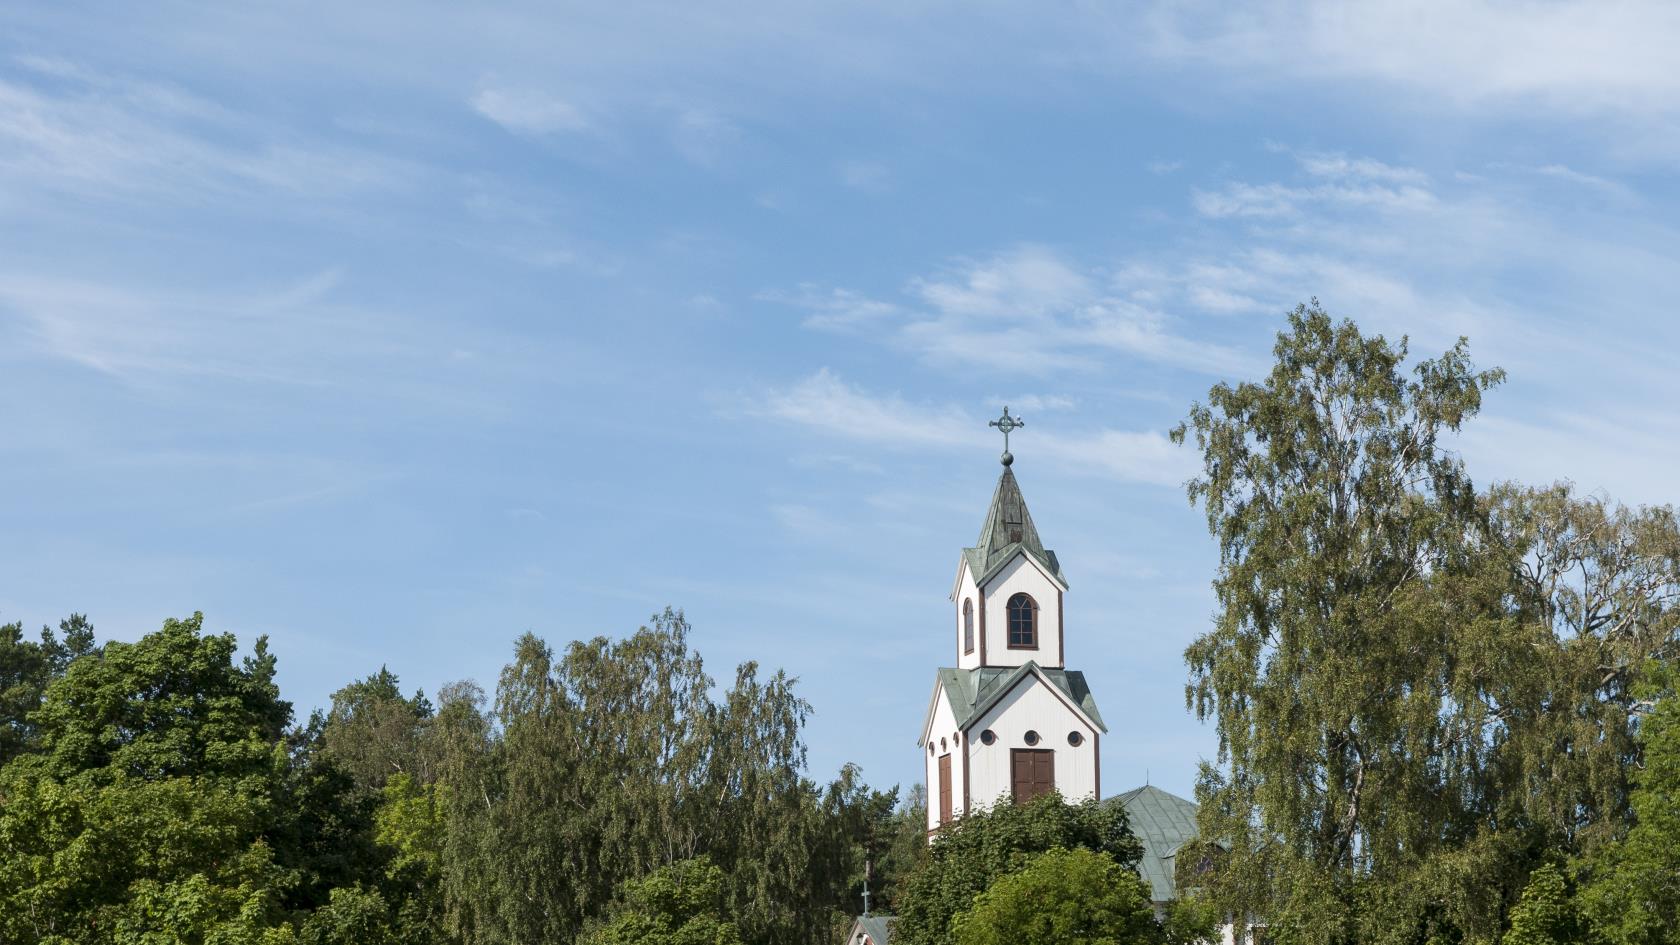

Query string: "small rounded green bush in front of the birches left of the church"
[[580, 856, 741, 945]]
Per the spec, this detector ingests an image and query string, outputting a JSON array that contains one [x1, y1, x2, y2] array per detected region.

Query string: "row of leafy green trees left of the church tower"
[[0, 610, 924, 945]]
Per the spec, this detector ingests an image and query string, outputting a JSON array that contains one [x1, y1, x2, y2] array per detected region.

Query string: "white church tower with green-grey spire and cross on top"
[[919, 409, 1107, 834]]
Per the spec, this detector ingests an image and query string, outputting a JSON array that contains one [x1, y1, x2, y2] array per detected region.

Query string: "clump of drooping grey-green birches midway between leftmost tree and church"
[[428, 610, 879, 945]]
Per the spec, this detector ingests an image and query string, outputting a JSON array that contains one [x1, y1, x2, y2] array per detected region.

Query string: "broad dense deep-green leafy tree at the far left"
[[0, 614, 418, 945]]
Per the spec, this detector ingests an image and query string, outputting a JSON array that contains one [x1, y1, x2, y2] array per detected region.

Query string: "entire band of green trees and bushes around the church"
[[0, 303, 1680, 945]]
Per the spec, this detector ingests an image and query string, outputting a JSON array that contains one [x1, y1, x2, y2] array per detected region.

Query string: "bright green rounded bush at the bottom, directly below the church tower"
[[953, 849, 1161, 945]]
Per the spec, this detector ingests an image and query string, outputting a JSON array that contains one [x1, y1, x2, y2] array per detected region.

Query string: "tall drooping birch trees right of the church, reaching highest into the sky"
[[1174, 301, 1680, 945]]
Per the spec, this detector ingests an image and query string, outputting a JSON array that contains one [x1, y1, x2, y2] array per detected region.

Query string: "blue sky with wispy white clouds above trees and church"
[[0, 0, 1680, 794]]
